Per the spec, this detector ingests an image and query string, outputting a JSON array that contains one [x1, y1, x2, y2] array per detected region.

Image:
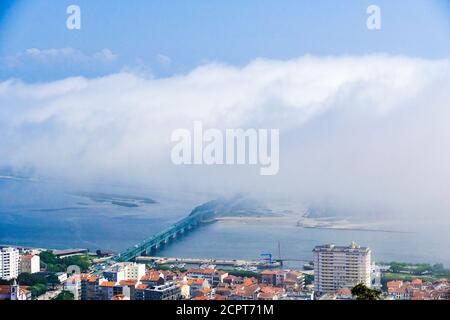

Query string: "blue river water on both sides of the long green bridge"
[[0, 179, 450, 267]]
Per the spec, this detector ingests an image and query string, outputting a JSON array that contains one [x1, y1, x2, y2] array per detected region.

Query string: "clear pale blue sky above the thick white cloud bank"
[[0, 0, 450, 81]]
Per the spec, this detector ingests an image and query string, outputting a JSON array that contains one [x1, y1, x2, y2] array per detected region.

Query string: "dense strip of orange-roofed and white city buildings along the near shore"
[[0, 243, 450, 301]]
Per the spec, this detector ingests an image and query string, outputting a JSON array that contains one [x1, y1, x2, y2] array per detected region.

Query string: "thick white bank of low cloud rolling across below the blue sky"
[[0, 53, 450, 221]]
